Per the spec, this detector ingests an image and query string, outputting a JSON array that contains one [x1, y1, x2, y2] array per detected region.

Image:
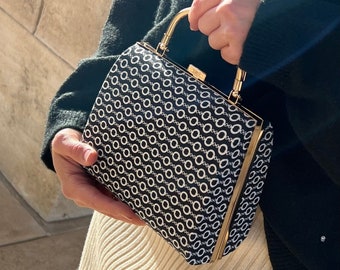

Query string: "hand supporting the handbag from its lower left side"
[[51, 129, 145, 225]]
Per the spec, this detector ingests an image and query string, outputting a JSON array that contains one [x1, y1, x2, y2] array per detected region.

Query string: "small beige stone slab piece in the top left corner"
[[0, 0, 42, 32]]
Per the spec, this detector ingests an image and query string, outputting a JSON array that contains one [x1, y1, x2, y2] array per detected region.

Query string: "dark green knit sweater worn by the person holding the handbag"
[[41, 0, 340, 270]]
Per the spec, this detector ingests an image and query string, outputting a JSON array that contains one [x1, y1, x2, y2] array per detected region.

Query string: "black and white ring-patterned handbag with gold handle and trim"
[[83, 9, 273, 265]]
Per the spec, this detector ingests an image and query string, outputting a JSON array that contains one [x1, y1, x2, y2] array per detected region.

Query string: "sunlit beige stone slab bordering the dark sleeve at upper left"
[[36, 0, 111, 66]]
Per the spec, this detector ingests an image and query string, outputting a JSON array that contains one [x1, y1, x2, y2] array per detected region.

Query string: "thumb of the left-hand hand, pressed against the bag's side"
[[51, 128, 98, 166]]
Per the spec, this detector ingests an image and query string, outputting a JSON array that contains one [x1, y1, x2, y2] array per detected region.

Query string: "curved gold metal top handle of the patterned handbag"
[[156, 8, 247, 104]]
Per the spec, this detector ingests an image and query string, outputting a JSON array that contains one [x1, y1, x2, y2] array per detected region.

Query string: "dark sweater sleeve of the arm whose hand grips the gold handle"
[[240, 0, 340, 185]]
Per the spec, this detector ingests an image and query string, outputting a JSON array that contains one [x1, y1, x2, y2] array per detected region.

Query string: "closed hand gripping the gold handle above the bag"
[[188, 0, 261, 65]]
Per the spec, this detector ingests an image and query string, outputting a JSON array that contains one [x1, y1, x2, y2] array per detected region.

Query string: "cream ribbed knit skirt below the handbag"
[[79, 212, 272, 270]]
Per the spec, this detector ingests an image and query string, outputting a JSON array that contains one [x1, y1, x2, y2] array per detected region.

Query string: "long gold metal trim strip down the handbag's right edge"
[[210, 125, 263, 263]]
